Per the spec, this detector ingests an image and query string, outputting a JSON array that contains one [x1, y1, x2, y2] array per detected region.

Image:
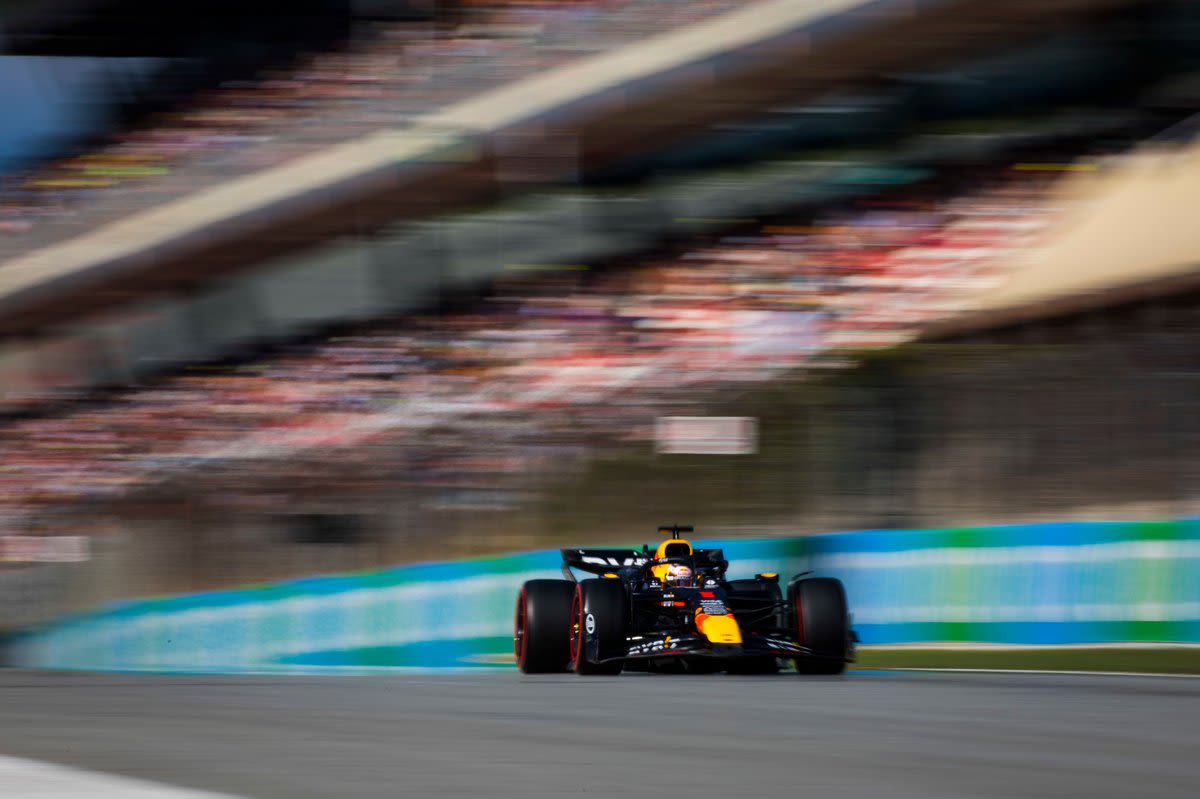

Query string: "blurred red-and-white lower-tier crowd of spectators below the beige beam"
[[0, 157, 1070, 519]]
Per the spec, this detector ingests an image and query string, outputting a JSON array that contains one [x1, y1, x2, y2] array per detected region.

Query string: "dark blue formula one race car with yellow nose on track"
[[514, 525, 856, 674]]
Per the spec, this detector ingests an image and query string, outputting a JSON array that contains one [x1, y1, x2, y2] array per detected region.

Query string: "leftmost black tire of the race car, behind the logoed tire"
[[512, 579, 575, 674]]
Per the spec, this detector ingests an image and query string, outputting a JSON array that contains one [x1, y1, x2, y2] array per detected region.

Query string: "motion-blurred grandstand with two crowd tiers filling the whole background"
[[0, 0, 1200, 614]]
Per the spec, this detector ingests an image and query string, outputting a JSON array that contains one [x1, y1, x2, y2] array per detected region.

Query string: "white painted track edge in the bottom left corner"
[[0, 755, 243, 799]]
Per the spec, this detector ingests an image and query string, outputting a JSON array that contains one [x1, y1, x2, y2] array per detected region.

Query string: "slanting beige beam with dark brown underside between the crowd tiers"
[[0, 0, 1134, 335]]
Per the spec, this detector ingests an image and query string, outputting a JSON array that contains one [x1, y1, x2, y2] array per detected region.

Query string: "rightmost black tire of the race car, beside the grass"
[[787, 577, 851, 674]]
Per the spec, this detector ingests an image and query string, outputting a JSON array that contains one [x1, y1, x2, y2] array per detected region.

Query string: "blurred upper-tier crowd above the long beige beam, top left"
[[0, 0, 743, 251]]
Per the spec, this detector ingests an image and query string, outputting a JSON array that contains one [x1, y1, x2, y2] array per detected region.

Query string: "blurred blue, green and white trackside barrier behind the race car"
[[11, 519, 1200, 672]]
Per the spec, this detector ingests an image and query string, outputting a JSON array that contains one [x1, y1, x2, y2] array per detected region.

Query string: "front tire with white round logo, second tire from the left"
[[568, 579, 629, 675]]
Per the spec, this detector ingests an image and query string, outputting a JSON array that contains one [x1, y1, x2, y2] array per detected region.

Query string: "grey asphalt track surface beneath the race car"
[[0, 669, 1200, 799]]
